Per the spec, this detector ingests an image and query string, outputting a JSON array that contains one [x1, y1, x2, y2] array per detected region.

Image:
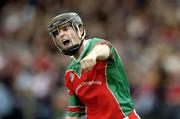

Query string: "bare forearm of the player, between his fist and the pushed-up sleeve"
[[90, 44, 110, 60]]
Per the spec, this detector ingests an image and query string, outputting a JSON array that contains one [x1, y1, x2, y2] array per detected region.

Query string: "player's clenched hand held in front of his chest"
[[80, 53, 96, 71]]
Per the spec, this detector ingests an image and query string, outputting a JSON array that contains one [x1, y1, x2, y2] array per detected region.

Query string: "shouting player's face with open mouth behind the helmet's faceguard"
[[51, 25, 81, 49]]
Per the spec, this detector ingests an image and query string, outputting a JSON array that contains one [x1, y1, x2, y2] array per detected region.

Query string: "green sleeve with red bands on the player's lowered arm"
[[67, 89, 85, 117]]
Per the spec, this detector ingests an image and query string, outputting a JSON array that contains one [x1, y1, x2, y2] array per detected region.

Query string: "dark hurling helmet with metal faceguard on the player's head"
[[48, 12, 86, 56]]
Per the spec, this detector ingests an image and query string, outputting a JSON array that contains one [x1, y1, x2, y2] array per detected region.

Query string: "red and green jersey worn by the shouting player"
[[65, 38, 139, 119]]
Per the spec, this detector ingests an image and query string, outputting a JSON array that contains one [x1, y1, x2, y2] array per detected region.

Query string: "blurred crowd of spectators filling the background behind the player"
[[0, 0, 180, 119]]
